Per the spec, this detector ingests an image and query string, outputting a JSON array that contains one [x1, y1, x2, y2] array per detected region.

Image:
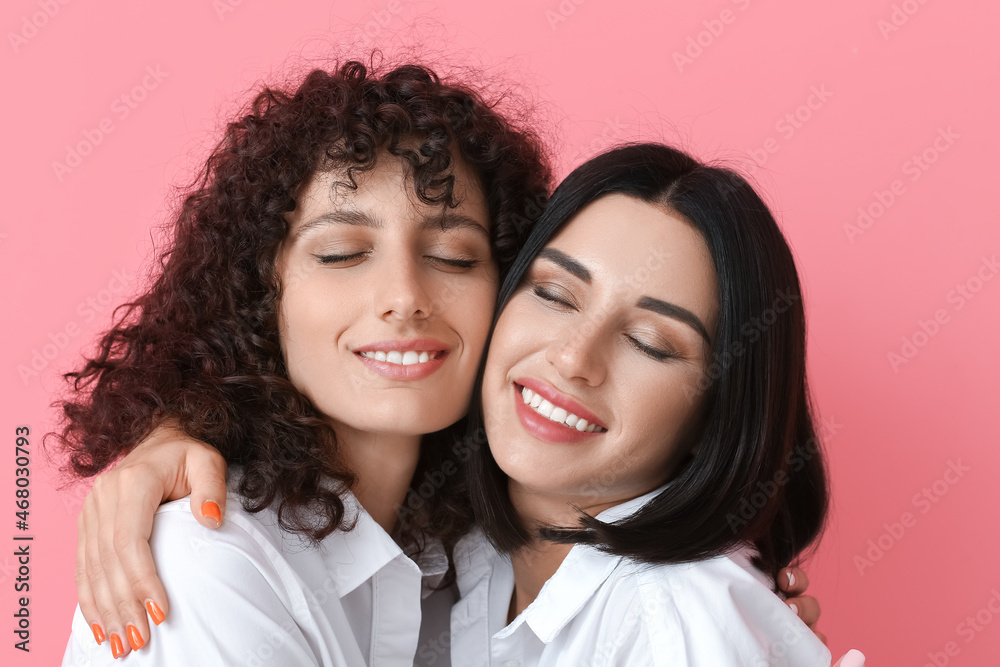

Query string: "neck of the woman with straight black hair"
[[507, 480, 621, 623]]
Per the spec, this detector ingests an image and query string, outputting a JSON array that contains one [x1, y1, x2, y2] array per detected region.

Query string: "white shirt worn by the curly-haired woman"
[[63, 492, 447, 667]]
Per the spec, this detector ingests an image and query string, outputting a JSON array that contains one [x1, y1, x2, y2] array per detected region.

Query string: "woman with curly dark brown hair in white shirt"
[[60, 62, 549, 665]]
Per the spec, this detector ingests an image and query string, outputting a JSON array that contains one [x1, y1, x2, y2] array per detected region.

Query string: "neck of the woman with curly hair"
[[336, 428, 420, 534]]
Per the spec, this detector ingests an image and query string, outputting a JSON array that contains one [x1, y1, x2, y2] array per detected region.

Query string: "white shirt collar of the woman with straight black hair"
[[496, 485, 666, 644]]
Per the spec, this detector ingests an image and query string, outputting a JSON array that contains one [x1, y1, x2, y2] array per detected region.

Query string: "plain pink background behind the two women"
[[0, 0, 1000, 667]]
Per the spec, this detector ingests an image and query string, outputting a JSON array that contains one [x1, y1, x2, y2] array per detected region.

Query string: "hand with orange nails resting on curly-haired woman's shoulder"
[[74, 427, 226, 655]]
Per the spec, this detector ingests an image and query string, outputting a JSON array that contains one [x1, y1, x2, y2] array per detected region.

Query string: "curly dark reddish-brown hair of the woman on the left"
[[54, 61, 551, 542]]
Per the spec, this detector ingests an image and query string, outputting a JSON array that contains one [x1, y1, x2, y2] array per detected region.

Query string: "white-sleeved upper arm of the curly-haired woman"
[[63, 501, 320, 667]]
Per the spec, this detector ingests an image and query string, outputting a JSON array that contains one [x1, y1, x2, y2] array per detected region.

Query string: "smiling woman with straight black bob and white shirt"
[[452, 144, 830, 666]]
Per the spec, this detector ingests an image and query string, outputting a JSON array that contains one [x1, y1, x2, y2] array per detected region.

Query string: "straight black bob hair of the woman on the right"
[[468, 144, 828, 576]]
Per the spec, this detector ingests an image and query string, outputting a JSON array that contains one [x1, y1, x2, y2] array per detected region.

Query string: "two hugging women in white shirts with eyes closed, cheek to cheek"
[[61, 62, 860, 667]]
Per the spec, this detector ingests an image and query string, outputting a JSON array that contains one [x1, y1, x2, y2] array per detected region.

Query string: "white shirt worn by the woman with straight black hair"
[[451, 490, 830, 667]]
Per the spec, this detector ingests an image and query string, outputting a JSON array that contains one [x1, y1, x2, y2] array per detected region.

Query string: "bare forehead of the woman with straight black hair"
[[548, 194, 718, 330]]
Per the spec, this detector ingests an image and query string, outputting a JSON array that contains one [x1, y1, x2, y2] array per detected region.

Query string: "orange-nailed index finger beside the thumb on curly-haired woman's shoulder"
[[113, 467, 170, 637]]
